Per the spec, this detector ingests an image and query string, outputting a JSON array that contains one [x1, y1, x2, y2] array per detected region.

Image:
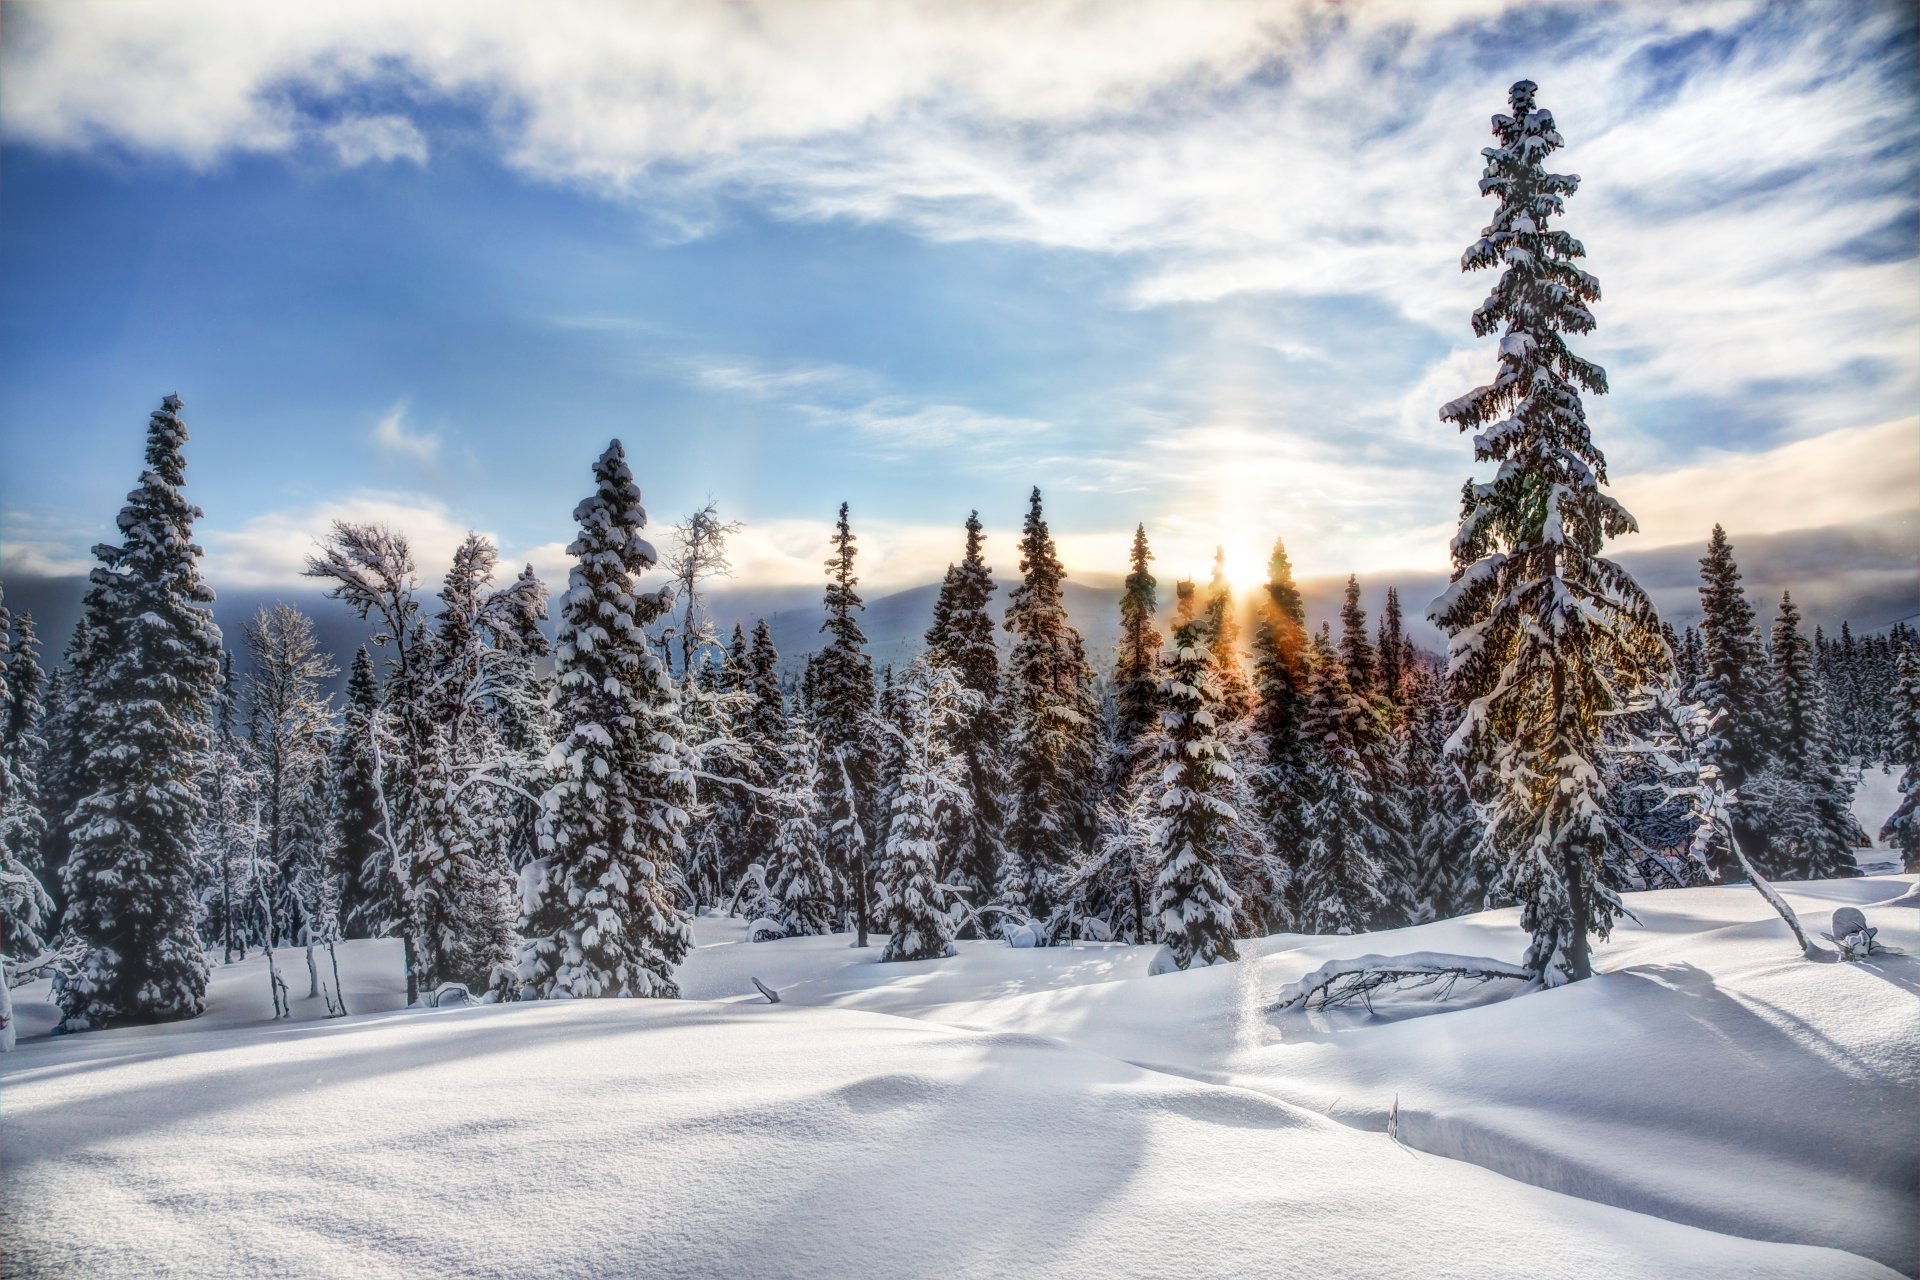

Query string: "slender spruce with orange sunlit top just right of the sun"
[[1248, 537, 1317, 929]]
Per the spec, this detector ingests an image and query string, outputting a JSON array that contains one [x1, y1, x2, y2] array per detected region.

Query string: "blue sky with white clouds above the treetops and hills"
[[0, 0, 1920, 610]]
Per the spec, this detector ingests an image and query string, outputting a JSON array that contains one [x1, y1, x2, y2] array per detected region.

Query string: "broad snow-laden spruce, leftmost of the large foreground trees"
[[60, 395, 221, 1031]]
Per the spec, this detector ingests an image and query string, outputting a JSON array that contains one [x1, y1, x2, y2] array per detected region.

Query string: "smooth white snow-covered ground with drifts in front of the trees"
[[0, 877, 1920, 1280]]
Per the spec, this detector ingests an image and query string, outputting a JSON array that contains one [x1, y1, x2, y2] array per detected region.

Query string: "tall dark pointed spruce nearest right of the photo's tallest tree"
[[1688, 524, 1776, 879]]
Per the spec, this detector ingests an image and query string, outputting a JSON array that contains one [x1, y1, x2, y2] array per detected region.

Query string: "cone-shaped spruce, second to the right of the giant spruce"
[[1741, 593, 1860, 881]]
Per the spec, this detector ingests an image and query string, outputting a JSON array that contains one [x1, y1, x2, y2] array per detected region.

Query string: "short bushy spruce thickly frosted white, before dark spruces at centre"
[[874, 654, 983, 960]]
